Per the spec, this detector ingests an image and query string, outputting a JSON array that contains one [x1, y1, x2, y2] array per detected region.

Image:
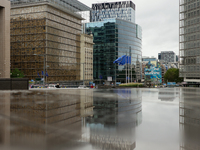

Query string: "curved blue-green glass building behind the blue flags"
[[84, 18, 142, 82]]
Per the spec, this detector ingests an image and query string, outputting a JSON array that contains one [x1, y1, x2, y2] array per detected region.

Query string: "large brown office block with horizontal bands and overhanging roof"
[[10, 0, 90, 82]]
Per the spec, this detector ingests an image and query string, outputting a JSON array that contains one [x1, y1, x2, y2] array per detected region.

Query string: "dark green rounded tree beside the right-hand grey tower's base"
[[164, 68, 183, 83]]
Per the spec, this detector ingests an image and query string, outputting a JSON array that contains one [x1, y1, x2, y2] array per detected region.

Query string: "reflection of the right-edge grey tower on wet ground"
[[179, 88, 200, 150]]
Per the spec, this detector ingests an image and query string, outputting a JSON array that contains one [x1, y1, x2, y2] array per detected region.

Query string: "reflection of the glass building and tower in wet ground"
[[86, 89, 142, 150]]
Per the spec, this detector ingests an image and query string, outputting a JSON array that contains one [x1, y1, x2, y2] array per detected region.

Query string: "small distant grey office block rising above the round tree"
[[158, 51, 176, 63]]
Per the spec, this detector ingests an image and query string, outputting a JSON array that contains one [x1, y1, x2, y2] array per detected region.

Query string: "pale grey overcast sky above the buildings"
[[79, 0, 179, 57]]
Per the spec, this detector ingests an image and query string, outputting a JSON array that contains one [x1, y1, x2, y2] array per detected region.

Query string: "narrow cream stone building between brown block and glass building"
[[80, 34, 94, 85]]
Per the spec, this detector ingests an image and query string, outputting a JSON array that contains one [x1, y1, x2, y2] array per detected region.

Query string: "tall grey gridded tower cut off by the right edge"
[[179, 0, 200, 82]]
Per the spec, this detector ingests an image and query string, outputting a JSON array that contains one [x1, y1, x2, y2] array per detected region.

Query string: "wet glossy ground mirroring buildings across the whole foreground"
[[0, 88, 200, 150]]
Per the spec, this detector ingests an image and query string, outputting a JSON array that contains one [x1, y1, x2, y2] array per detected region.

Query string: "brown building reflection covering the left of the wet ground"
[[0, 90, 93, 150]]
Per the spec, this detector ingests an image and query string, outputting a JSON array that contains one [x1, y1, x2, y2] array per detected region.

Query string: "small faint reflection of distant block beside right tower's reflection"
[[158, 88, 179, 102]]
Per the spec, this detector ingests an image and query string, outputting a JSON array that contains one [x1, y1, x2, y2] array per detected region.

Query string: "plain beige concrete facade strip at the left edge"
[[0, 0, 10, 78]]
